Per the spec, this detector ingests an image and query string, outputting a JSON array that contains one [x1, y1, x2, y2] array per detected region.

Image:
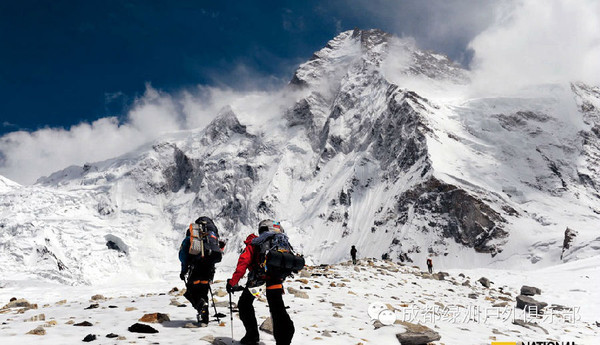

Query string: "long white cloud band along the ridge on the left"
[[0, 85, 296, 184]]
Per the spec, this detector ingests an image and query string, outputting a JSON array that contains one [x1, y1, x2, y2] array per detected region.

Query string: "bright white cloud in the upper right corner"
[[469, 0, 600, 93]]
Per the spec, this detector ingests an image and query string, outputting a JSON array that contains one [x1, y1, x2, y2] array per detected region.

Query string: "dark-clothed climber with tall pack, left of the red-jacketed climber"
[[179, 217, 225, 326]]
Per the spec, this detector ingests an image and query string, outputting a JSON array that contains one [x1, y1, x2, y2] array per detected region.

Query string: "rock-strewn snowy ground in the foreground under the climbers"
[[0, 256, 600, 345]]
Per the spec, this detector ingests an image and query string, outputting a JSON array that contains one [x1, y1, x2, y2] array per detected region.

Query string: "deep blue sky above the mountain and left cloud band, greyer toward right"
[[0, 0, 493, 134]]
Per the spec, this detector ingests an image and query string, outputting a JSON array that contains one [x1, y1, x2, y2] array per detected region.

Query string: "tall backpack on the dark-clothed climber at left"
[[189, 217, 223, 264]]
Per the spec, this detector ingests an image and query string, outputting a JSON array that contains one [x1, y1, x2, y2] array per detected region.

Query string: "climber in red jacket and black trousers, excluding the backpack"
[[226, 219, 295, 345]]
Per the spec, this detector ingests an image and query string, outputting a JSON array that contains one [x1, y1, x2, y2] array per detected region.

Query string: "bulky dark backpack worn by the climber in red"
[[252, 231, 305, 281]]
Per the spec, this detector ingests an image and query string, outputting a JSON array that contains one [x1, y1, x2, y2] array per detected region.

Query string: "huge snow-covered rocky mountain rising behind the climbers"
[[0, 29, 600, 283]]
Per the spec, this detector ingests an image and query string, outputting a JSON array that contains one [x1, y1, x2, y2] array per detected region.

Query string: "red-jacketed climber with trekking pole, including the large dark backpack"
[[226, 219, 304, 345]]
